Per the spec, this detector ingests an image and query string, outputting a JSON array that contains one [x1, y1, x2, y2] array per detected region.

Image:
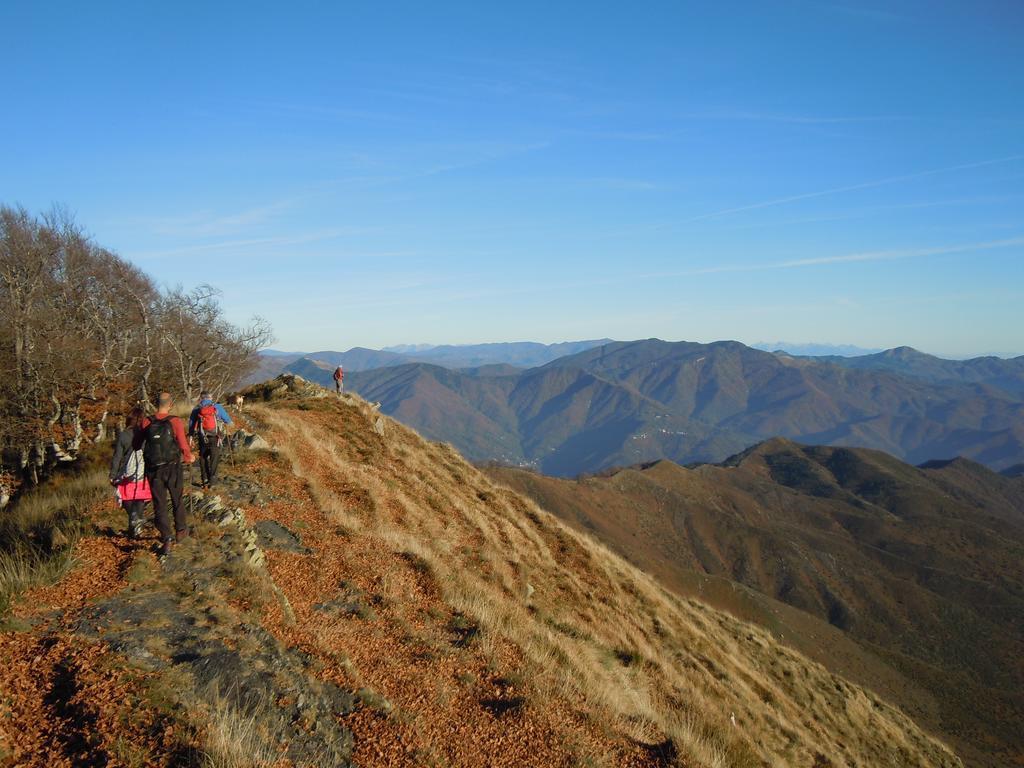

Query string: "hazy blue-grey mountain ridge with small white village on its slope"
[[344, 339, 1024, 475]]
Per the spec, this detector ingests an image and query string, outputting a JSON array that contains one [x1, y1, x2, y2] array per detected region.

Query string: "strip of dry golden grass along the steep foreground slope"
[[254, 398, 959, 768]]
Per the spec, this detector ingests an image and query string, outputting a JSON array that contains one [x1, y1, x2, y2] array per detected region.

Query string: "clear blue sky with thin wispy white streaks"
[[0, 0, 1024, 355]]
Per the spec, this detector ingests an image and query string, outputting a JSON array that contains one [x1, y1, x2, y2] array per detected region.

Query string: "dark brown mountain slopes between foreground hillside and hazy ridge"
[[488, 439, 1024, 768]]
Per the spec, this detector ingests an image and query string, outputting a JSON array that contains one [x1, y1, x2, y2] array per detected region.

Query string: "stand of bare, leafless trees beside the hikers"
[[0, 207, 270, 499]]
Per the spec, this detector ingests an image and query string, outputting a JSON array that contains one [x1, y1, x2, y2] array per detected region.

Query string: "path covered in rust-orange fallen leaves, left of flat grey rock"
[[0, 502, 178, 768]]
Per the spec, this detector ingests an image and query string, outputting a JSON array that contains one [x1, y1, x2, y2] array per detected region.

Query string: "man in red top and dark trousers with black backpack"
[[132, 392, 196, 557]]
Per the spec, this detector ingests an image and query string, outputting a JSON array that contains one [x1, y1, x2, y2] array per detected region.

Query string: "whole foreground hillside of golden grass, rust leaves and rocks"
[[0, 383, 959, 768]]
